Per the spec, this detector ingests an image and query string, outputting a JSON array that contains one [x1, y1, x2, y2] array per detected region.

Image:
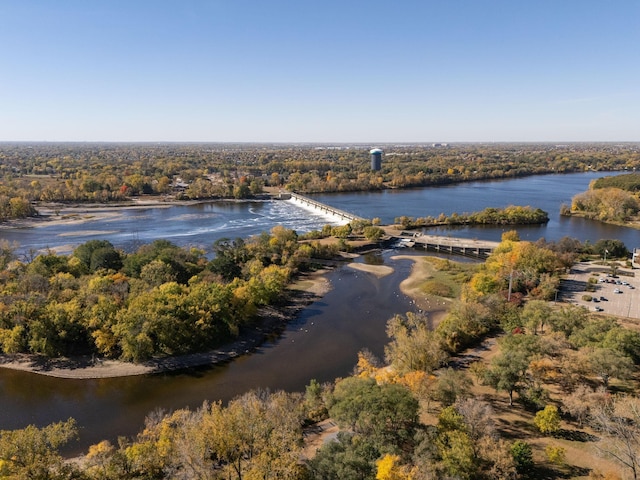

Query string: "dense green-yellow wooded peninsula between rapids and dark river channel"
[[0, 222, 358, 362]]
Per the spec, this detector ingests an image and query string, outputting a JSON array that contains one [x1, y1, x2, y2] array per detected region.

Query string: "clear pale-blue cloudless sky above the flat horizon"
[[0, 0, 640, 144]]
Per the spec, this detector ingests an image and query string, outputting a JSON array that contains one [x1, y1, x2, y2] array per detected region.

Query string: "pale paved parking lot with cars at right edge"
[[560, 262, 640, 319]]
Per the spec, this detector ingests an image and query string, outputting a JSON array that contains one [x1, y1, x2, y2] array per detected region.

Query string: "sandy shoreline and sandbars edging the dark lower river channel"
[[0, 251, 447, 380]]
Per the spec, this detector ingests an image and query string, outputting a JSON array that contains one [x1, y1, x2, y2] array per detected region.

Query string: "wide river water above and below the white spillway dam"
[[0, 172, 640, 453]]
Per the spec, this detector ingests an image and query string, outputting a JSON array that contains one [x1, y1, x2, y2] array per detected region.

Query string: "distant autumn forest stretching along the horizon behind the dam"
[[0, 143, 640, 221]]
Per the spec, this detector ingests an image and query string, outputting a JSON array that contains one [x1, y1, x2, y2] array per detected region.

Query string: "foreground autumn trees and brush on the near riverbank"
[[0, 232, 640, 480]]
